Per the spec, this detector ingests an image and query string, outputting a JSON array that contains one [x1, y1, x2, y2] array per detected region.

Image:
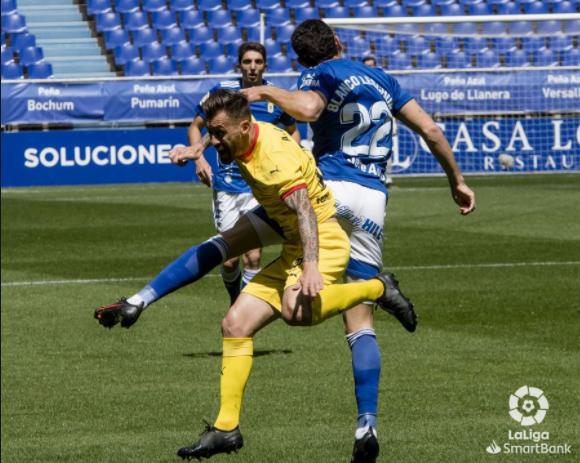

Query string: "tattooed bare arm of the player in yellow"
[[284, 188, 323, 297]]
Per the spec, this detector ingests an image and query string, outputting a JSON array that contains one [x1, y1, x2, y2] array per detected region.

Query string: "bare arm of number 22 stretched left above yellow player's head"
[[241, 85, 326, 122]]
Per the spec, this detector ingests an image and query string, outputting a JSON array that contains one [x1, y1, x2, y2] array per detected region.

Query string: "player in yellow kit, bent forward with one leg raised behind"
[[178, 89, 412, 459]]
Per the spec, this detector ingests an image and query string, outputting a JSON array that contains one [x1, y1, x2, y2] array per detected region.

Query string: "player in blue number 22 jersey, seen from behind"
[[243, 20, 475, 463]]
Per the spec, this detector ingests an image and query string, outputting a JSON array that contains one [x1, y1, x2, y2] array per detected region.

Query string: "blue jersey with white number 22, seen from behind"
[[298, 59, 412, 193]]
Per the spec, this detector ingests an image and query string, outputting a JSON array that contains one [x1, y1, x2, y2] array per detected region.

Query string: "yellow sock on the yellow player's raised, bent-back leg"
[[312, 278, 385, 325]]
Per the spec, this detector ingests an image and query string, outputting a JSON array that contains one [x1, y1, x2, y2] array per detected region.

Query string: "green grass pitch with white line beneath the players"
[[2, 175, 580, 463]]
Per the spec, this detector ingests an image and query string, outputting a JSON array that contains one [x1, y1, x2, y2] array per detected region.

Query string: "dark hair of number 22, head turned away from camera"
[[292, 19, 338, 68]]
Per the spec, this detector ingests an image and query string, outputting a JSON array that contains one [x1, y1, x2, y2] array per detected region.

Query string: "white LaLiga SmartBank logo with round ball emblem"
[[485, 386, 572, 455]]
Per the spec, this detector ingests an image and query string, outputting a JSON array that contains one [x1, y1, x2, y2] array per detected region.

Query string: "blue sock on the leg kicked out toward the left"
[[136, 235, 229, 306]]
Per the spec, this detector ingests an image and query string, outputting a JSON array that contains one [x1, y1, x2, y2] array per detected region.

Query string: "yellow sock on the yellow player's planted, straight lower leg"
[[214, 338, 254, 431]]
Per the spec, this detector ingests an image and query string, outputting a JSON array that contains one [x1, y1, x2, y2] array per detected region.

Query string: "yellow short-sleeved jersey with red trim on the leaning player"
[[237, 122, 336, 241]]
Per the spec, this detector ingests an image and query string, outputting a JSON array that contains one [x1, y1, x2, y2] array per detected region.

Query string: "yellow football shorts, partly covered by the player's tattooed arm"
[[242, 220, 350, 311]]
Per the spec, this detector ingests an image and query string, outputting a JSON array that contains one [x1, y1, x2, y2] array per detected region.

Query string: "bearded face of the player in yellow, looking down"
[[207, 111, 251, 164]]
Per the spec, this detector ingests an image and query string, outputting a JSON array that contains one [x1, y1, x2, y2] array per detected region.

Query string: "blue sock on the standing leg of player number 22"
[[346, 328, 381, 428]]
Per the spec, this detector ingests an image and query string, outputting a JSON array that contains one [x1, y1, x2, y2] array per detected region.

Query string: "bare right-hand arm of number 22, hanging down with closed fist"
[[397, 100, 475, 215]]
